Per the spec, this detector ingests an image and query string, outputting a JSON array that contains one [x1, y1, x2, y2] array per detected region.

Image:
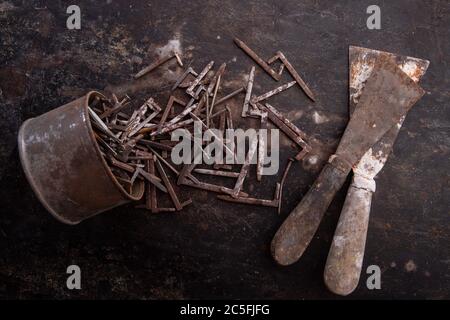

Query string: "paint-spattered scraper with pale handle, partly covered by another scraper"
[[324, 46, 429, 295]]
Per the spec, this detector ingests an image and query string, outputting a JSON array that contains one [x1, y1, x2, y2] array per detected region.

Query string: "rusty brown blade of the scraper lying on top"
[[335, 55, 424, 165]]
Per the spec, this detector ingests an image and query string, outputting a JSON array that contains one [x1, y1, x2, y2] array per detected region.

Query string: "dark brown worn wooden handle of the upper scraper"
[[271, 163, 350, 265]]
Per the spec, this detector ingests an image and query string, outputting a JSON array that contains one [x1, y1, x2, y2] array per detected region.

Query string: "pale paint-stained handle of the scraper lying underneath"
[[324, 175, 375, 296]]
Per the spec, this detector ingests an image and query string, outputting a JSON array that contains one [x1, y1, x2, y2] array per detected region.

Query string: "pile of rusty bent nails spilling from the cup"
[[88, 38, 314, 213]]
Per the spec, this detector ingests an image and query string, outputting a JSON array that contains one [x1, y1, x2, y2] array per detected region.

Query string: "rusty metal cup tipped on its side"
[[18, 91, 144, 224]]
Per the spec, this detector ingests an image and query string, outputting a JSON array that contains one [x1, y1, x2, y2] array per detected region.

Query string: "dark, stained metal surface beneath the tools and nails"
[[0, 0, 450, 299]]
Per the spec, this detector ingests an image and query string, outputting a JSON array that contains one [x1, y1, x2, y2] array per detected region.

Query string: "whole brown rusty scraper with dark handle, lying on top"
[[271, 57, 424, 265]]
